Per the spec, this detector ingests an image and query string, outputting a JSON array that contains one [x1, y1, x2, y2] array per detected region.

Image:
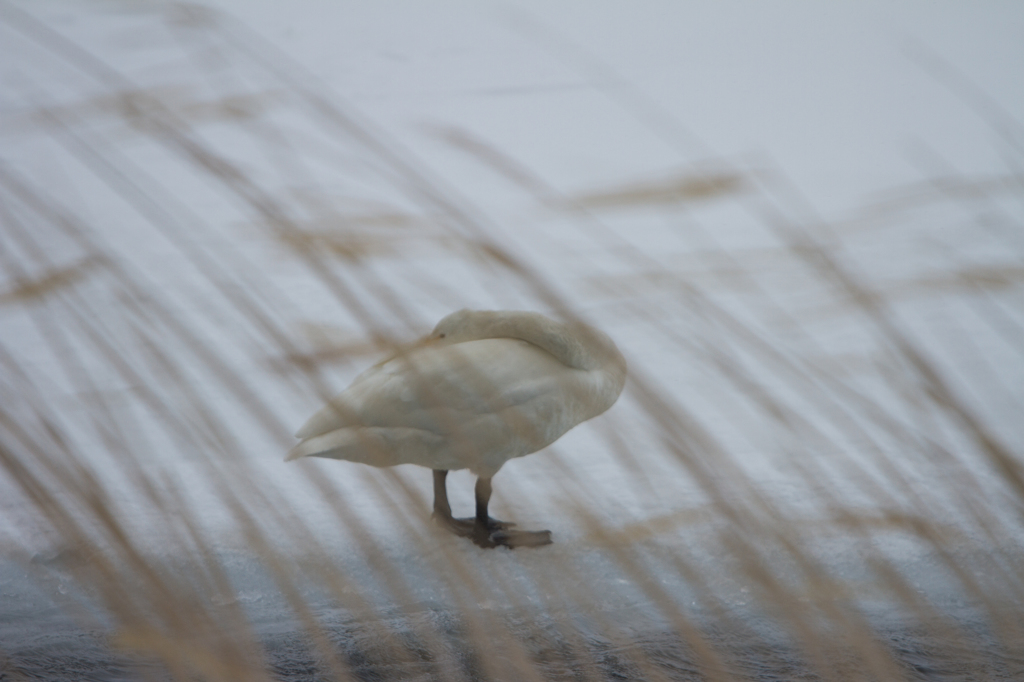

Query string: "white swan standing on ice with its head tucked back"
[[287, 310, 626, 547]]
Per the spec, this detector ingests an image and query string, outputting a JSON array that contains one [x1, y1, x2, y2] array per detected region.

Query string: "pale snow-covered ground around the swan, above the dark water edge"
[[0, 0, 1024, 679]]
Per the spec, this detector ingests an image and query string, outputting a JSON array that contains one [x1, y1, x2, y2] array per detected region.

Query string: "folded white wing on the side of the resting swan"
[[296, 339, 575, 438]]
